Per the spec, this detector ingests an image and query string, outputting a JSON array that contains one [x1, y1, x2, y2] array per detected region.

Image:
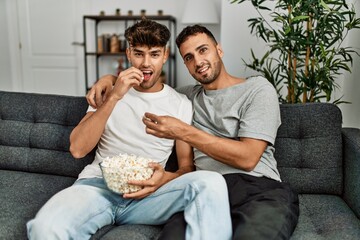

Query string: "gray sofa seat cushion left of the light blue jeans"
[[0, 170, 75, 239]]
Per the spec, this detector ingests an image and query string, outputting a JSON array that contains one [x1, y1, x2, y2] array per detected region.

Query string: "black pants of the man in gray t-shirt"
[[159, 174, 299, 240]]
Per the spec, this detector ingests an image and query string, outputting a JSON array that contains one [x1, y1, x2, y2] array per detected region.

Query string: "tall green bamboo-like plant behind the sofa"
[[231, 0, 360, 103]]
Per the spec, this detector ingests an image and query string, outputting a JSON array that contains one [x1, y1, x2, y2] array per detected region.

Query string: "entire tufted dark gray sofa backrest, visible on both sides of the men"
[[0, 91, 343, 194]]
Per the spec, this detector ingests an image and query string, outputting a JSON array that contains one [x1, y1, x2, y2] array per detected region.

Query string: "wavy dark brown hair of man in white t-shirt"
[[125, 18, 171, 47]]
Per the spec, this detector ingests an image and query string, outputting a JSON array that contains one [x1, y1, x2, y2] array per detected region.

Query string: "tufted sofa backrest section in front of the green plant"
[[275, 103, 343, 194]]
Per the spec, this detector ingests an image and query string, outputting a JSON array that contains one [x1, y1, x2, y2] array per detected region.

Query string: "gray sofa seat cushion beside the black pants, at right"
[[291, 194, 360, 240]]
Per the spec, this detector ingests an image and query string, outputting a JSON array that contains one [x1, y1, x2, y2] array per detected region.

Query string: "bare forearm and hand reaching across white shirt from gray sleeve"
[[143, 113, 267, 171]]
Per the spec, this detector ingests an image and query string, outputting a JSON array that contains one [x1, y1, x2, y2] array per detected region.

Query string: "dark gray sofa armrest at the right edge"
[[342, 128, 360, 218]]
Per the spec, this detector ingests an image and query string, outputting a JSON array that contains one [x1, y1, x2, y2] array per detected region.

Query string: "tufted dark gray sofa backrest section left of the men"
[[0, 91, 94, 177]]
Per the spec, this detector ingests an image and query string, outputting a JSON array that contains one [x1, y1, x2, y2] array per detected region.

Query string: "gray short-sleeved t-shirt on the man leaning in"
[[180, 77, 281, 181]]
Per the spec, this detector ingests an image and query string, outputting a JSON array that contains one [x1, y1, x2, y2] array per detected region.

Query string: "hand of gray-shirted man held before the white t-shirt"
[[142, 113, 189, 139]]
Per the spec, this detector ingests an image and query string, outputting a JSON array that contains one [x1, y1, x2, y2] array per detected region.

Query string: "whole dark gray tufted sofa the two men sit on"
[[0, 91, 360, 240]]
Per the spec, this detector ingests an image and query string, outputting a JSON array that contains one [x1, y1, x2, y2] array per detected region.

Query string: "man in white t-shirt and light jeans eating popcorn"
[[27, 20, 232, 240]]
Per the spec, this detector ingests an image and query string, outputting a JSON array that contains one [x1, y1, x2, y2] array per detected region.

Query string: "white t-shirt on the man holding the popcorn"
[[79, 84, 193, 178]]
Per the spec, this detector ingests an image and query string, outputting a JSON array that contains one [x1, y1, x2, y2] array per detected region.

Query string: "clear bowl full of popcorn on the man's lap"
[[100, 154, 154, 194]]
